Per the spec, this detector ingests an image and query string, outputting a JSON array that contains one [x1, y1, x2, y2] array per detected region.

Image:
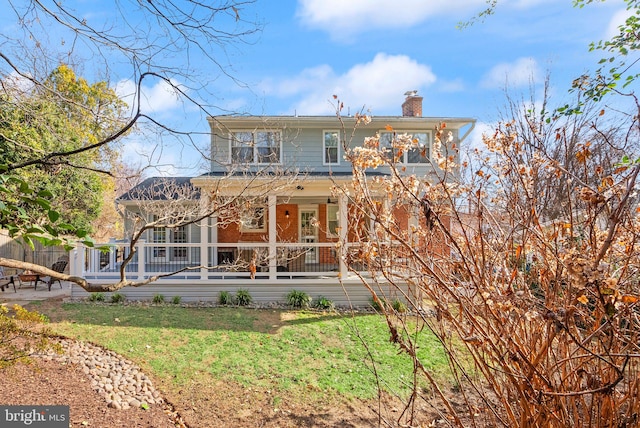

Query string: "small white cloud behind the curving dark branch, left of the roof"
[[116, 79, 182, 114]]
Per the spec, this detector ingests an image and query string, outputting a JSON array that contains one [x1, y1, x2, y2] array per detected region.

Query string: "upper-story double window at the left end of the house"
[[230, 131, 282, 164]]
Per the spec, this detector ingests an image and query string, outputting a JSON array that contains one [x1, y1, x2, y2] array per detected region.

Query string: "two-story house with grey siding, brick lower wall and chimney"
[[72, 92, 475, 304]]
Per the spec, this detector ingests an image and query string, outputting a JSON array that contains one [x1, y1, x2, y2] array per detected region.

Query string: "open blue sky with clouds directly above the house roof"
[[227, 0, 624, 120]]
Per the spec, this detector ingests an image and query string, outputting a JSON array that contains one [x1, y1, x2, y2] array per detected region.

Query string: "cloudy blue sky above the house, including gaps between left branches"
[[5, 0, 627, 175]]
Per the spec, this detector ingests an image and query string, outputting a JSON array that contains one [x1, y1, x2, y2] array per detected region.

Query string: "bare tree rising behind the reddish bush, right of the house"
[[498, 76, 638, 221]]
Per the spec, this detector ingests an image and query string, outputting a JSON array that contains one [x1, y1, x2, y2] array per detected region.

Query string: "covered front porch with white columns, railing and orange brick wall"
[[70, 174, 418, 305]]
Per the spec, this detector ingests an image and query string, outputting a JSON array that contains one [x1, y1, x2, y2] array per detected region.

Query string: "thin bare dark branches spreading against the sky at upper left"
[[0, 0, 259, 170]]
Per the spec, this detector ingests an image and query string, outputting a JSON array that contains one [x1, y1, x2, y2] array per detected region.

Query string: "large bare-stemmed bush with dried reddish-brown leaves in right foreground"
[[336, 95, 640, 427]]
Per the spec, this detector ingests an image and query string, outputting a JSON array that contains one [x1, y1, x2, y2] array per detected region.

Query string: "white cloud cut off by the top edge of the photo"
[[296, 0, 486, 38]]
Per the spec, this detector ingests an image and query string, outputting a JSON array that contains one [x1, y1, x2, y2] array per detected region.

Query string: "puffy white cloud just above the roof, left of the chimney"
[[262, 53, 436, 115]]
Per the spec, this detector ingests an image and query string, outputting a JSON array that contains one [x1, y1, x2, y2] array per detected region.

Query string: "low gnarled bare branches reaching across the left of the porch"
[[0, 166, 300, 292]]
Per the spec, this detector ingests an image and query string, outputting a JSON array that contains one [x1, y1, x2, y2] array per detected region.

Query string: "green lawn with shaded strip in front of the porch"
[[45, 304, 448, 399]]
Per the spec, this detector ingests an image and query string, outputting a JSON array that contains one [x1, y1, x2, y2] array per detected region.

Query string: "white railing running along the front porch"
[[71, 241, 358, 281]]
